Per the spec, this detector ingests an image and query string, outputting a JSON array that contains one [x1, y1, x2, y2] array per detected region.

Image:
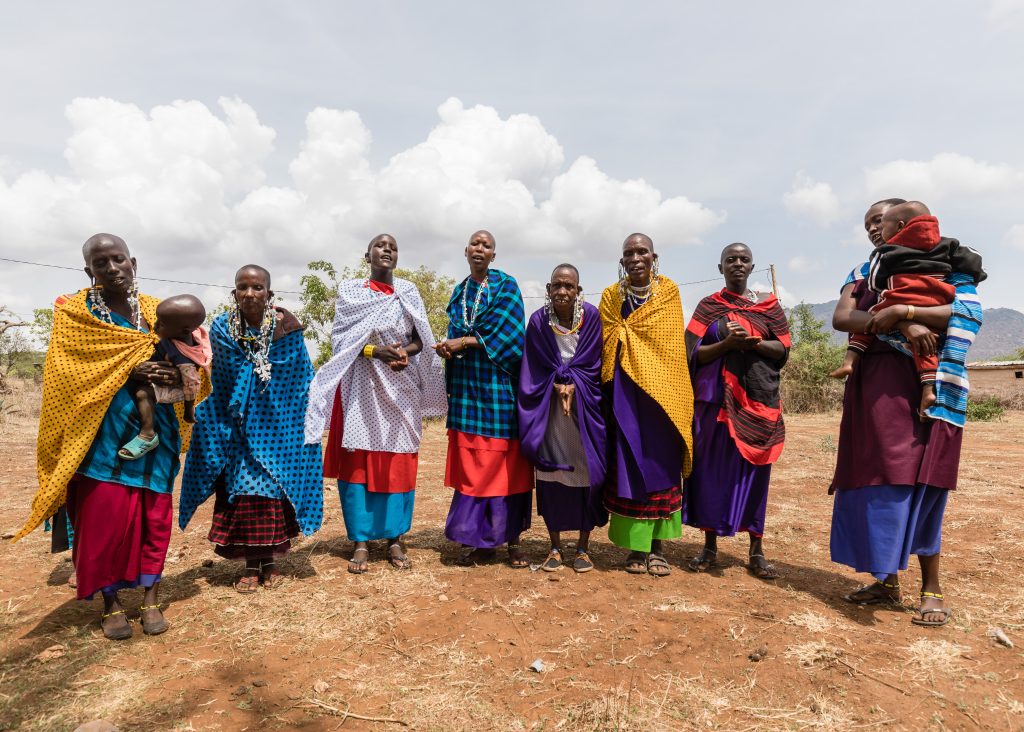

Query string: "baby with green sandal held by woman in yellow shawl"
[[118, 295, 211, 460]]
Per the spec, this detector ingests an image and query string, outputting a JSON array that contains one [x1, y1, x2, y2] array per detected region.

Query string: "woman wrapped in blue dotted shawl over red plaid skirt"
[[178, 264, 324, 594]]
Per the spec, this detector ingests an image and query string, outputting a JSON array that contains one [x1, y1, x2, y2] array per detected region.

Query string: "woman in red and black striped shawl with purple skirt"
[[683, 244, 790, 579]]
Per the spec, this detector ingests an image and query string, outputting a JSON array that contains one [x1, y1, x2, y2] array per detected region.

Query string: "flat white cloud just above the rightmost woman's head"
[[864, 153, 1024, 204]]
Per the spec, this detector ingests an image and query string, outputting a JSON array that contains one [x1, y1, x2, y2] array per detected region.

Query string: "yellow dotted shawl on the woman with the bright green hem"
[[599, 276, 693, 476]]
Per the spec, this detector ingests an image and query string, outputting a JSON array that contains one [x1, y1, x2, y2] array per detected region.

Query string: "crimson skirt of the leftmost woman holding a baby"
[[68, 475, 173, 600]]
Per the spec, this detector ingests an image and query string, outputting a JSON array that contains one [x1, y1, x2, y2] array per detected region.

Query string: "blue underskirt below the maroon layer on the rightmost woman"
[[830, 485, 949, 580]]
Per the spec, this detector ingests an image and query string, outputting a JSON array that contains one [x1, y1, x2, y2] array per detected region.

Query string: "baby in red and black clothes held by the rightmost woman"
[[829, 201, 987, 419]]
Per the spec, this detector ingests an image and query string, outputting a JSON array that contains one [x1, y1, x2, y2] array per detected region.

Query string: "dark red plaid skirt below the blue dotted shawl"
[[209, 485, 299, 559]]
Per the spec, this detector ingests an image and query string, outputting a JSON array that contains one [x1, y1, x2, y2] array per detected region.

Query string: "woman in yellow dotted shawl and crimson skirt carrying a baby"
[[14, 233, 203, 640]]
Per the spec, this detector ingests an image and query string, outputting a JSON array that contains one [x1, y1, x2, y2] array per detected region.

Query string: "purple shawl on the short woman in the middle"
[[518, 302, 606, 487]]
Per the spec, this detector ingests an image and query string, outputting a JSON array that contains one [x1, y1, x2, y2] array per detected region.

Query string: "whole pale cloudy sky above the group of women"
[[0, 0, 1024, 323]]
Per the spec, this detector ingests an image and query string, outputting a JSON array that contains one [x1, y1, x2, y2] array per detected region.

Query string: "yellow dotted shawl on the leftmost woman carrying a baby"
[[13, 289, 210, 542]]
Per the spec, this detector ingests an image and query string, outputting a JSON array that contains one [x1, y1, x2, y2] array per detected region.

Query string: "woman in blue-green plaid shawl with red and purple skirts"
[[436, 231, 534, 569]]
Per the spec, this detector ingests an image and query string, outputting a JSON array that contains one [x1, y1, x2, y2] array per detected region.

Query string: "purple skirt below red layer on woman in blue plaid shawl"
[[444, 490, 534, 549]]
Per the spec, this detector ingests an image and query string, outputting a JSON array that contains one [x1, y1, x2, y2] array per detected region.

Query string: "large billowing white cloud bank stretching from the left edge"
[[0, 98, 724, 309]]
